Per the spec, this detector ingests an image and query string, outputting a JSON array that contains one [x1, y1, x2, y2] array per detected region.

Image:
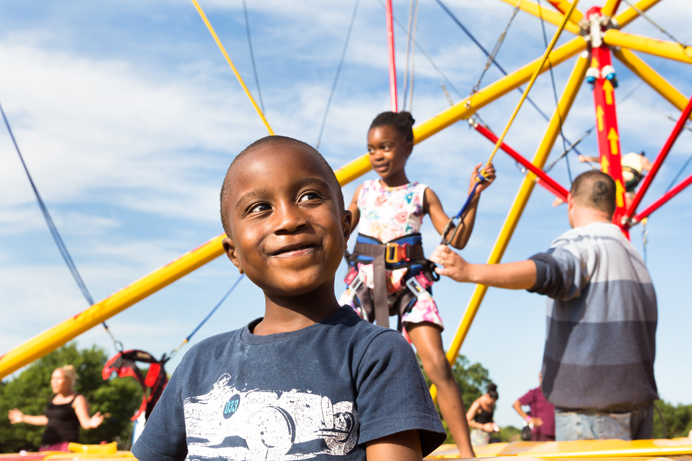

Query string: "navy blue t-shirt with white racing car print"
[[132, 307, 446, 461]]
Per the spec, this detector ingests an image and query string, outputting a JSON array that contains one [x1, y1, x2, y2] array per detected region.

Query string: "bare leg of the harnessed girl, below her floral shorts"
[[406, 322, 475, 458]]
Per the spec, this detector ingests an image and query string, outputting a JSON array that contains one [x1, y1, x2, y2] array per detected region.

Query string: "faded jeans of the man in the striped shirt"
[[555, 404, 654, 441]]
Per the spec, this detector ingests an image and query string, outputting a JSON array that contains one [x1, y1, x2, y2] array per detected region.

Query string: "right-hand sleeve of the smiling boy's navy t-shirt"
[[356, 330, 447, 456]]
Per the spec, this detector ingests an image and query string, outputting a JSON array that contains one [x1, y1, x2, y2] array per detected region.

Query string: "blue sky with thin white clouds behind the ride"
[[0, 0, 692, 425]]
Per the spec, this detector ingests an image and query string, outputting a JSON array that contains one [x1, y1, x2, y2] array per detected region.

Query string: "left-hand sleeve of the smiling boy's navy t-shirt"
[[132, 363, 187, 461]]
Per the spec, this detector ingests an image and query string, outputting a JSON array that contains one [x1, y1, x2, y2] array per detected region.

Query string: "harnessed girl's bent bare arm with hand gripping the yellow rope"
[[424, 163, 495, 249]]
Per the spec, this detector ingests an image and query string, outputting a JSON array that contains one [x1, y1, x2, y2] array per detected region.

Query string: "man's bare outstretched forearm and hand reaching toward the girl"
[[430, 245, 536, 290]]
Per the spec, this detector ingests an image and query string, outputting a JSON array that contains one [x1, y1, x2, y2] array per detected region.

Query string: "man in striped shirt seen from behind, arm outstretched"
[[430, 171, 658, 441]]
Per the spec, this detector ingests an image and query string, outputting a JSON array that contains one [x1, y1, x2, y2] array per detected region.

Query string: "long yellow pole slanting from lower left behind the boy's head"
[[0, 37, 586, 379]]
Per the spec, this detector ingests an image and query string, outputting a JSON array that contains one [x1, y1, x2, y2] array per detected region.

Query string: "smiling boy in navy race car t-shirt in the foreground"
[[132, 136, 445, 461]]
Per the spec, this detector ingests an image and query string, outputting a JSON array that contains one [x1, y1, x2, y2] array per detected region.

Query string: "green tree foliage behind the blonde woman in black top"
[[0, 342, 142, 453]]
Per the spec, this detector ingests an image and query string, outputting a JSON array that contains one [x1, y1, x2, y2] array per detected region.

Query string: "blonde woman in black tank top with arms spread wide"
[[9, 365, 103, 451]]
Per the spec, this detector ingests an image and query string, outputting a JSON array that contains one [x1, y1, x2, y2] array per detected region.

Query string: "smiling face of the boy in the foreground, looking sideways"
[[223, 144, 351, 296]]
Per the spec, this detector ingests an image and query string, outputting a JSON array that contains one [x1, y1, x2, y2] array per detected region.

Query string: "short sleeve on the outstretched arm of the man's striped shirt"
[[528, 245, 589, 301]]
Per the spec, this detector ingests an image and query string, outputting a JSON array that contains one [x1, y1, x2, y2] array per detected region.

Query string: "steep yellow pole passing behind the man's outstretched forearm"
[[430, 56, 590, 399]]
